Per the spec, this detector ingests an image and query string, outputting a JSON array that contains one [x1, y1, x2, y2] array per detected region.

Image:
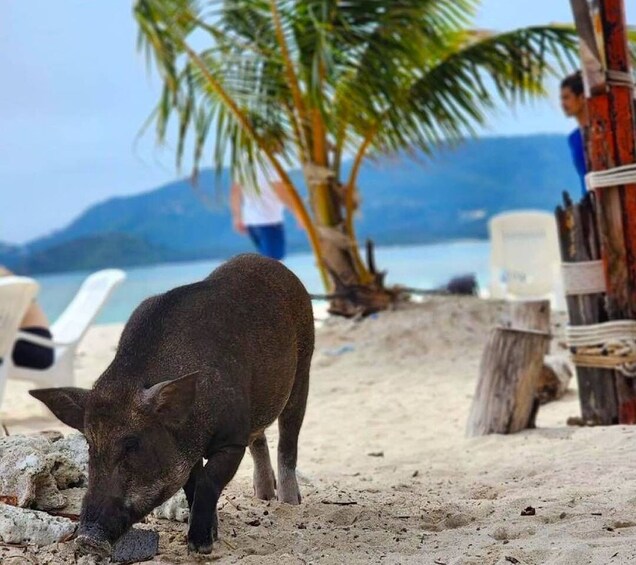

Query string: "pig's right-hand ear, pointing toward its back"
[[143, 371, 199, 425]]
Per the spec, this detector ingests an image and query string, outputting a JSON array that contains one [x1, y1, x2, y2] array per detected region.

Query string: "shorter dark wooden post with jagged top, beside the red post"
[[556, 194, 618, 420]]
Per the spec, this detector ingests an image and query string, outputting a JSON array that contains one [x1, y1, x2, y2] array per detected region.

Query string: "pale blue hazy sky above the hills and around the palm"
[[0, 0, 636, 243]]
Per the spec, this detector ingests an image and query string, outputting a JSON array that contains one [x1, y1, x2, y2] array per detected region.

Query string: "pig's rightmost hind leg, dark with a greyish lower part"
[[278, 355, 311, 504]]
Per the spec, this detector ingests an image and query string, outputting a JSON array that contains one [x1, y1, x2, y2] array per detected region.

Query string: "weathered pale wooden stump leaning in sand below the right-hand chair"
[[467, 300, 550, 437]]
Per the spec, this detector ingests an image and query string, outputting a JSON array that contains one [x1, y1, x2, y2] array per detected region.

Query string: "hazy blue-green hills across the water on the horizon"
[[0, 136, 579, 273]]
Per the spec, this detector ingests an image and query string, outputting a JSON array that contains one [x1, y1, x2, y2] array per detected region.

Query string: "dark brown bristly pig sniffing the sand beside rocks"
[[31, 254, 314, 556]]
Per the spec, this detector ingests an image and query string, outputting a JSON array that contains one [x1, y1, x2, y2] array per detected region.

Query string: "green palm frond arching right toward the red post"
[[356, 26, 576, 151]]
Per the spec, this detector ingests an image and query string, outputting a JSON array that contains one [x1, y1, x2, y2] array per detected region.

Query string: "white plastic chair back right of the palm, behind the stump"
[[488, 210, 564, 309]]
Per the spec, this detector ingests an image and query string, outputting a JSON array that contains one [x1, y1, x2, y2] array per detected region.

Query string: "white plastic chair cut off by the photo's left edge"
[[0, 276, 39, 404]]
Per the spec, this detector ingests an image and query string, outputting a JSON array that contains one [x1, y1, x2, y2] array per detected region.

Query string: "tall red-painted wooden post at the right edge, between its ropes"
[[571, 0, 636, 424]]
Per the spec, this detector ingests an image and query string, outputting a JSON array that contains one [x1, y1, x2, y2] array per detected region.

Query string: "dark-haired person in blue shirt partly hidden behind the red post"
[[561, 71, 587, 196]]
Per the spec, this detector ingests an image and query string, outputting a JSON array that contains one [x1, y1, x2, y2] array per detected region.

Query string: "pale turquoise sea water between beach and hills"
[[37, 241, 490, 324]]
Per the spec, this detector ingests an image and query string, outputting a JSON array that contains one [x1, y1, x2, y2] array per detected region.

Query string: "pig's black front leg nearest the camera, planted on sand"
[[186, 445, 245, 553]]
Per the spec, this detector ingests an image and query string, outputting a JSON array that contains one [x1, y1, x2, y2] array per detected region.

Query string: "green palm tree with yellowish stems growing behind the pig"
[[134, 0, 576, 315]]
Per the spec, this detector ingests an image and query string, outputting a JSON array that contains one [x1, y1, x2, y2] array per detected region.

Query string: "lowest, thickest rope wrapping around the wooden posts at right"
[[566, 320, 636, 377]]
